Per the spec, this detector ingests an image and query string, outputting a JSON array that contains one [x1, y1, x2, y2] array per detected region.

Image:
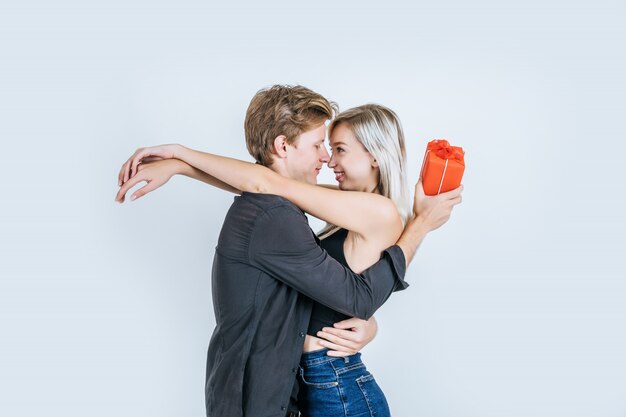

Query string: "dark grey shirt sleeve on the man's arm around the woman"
[[248, 205, 408, 319]]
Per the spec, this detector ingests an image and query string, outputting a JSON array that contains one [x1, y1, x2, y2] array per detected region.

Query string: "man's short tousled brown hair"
[[244, 85, 338, 166]]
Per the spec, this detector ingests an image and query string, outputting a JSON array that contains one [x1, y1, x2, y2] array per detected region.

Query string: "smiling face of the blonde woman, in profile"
[[328, 123, 379, 193]]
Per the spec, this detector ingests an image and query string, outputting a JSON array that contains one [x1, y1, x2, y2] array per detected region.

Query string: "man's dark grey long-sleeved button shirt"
[[205, 192, 408, 417]]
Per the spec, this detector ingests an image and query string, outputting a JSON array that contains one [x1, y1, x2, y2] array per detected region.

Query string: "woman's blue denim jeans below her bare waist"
[[298, 349, 391, 417]]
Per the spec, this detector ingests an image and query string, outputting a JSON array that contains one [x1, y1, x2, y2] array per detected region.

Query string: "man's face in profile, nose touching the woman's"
[[285, 123, 330, 185]]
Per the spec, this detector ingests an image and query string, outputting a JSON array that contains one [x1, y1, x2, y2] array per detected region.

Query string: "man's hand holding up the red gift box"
[[413, 178, 463, 231]]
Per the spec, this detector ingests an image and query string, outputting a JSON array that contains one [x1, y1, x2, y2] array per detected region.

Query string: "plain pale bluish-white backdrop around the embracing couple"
[[0, 0, 626, 417]]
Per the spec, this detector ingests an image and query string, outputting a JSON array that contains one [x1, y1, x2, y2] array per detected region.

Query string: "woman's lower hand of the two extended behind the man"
[[115, 159, 184, 203]]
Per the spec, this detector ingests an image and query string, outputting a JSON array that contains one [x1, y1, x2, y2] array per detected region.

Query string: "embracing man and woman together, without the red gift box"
[[116, 85, 463, 417]]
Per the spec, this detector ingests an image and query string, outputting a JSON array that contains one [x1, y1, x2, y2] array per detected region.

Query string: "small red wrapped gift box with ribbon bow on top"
[[420, 139, 465, 195]]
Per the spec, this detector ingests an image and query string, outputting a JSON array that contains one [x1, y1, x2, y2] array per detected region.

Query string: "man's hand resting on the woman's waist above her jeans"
[[317, 317, 378, 357]]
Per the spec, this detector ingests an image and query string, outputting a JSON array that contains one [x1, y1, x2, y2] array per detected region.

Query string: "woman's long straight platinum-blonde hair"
[[318, 104, 411, 239]]
